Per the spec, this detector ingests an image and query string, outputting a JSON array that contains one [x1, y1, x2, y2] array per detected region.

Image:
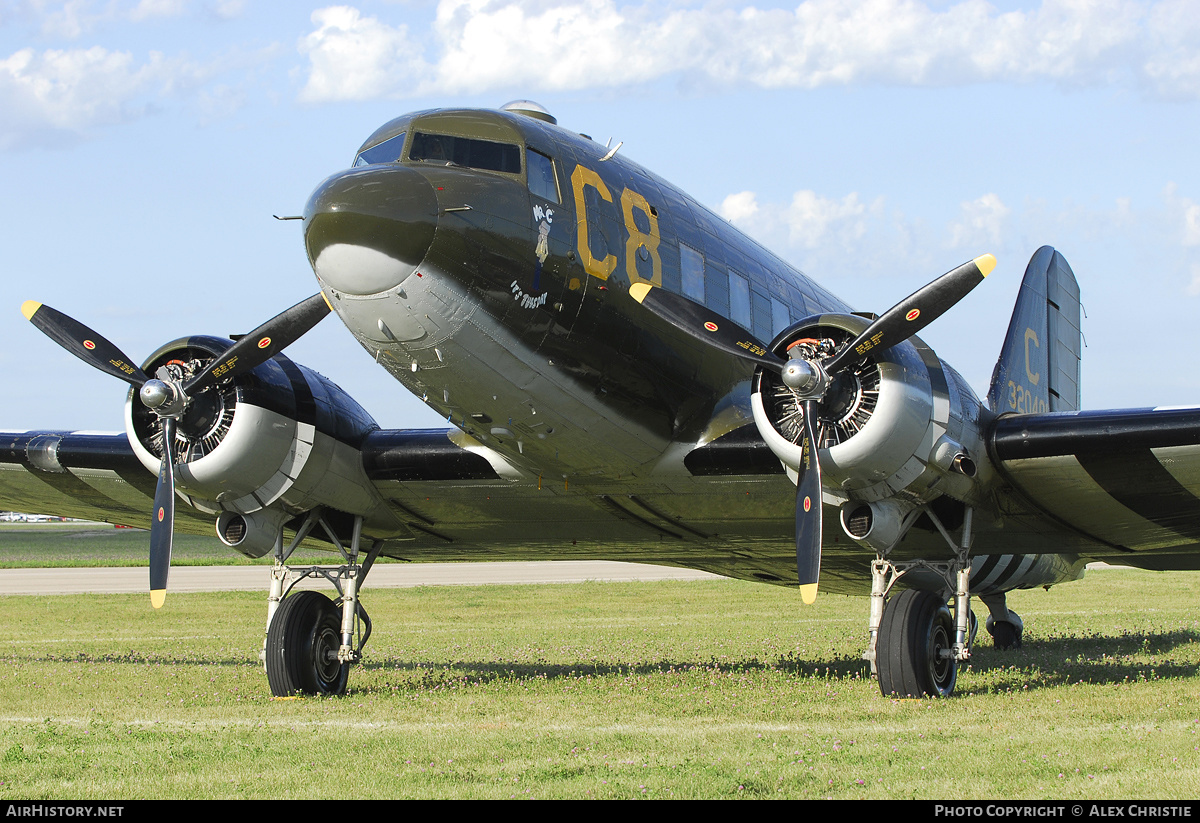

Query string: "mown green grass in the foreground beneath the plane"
[[0, 527, 1200, 799]]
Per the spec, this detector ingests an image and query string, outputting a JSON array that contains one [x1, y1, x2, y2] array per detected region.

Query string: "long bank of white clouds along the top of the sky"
[[300, 0, 1200, 100]]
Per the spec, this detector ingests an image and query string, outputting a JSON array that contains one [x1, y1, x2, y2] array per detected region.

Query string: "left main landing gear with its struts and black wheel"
[[263, 510, 383, 697]]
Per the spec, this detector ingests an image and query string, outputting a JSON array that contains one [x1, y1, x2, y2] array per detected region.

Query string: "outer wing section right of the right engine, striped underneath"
[[990, 408, 1200, 569]]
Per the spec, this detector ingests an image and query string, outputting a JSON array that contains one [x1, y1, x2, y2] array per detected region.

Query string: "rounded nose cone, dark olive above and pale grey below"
[[304, 164, 438, 295]]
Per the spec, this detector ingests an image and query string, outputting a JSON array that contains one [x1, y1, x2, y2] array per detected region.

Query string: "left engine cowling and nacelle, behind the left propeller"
[[125, 337, 403, 557]]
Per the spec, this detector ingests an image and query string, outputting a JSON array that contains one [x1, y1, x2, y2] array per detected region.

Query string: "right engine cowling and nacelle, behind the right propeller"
[[751, 314, 990, 539]]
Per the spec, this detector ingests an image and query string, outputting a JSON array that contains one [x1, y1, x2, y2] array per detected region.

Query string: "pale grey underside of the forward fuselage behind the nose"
[[335, 260, 667, 477]]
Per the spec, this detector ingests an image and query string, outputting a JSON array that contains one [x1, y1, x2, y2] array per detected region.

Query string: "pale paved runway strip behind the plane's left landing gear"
[[0, 560, 719, 595]]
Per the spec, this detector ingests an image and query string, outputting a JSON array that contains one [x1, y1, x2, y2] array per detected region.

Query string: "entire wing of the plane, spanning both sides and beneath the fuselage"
[[11, 408, 1200, 591]]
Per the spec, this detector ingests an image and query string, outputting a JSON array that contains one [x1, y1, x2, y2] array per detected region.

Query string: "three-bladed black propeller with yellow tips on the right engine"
[[629, 254, 996, 603]]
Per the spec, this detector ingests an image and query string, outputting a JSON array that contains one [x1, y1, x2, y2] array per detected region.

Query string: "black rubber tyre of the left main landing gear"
[[266, 591, 350, 697]]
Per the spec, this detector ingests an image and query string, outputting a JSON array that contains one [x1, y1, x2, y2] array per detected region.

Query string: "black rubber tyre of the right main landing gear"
[[876, 589, 959, 697]]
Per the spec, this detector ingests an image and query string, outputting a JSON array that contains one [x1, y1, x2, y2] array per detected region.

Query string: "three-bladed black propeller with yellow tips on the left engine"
[[20, 294, 330, 608]]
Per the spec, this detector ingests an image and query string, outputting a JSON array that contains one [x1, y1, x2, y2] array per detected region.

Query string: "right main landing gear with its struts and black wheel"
[[863, 507, 978, 697]]
